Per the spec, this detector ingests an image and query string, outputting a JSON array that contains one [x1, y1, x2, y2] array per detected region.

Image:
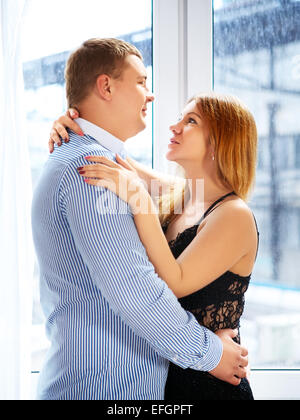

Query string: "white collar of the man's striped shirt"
[[75, 118, 127, 156]]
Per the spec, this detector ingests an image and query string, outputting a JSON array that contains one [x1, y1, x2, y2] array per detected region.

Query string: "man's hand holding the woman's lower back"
[[210, 330, 248, 385]]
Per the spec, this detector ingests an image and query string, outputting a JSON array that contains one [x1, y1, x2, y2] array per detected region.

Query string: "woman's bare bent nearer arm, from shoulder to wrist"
[[134, 197, 253, 298]]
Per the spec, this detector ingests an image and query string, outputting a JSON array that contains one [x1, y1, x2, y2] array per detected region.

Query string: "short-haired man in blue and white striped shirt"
[[32, 39, 247, 400]]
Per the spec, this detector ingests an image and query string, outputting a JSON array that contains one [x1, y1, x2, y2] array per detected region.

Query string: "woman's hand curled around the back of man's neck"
[[48, 108, 84, 153]]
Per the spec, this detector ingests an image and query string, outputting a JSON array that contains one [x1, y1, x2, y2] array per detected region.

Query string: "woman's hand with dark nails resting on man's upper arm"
[[77, 155, 151, 213]]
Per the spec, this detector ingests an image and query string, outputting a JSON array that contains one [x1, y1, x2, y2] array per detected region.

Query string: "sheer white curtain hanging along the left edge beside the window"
[[0, 0, 34, 400]]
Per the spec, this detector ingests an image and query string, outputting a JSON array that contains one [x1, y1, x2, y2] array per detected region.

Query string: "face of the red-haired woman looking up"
[[166, 101, 214, 168]]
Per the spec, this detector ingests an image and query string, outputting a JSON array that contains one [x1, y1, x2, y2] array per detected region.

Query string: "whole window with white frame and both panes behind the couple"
[[23, 0, 300, 398]]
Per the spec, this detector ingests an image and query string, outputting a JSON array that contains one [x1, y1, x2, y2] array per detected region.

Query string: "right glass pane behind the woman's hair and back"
[[214, 0, 300, 367]]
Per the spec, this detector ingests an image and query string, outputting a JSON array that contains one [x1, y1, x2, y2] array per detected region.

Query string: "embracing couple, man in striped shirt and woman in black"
[[32, 39, 258, 401]]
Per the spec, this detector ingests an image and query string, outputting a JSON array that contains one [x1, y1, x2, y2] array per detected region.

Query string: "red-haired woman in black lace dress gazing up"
[[48, 94, 258, 400]]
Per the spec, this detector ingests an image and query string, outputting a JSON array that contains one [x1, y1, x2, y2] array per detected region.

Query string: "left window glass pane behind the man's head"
[[22, 0, 152, 370]]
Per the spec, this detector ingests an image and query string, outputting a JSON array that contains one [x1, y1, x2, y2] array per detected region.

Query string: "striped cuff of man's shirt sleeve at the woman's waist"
[[190, 331, 223, 372]]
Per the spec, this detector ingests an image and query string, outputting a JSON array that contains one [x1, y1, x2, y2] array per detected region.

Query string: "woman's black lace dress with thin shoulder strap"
[[163, 193, 253, 401]]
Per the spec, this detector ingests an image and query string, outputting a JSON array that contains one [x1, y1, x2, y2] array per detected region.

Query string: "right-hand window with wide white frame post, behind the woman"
[[153, 0, 300, 399]]
